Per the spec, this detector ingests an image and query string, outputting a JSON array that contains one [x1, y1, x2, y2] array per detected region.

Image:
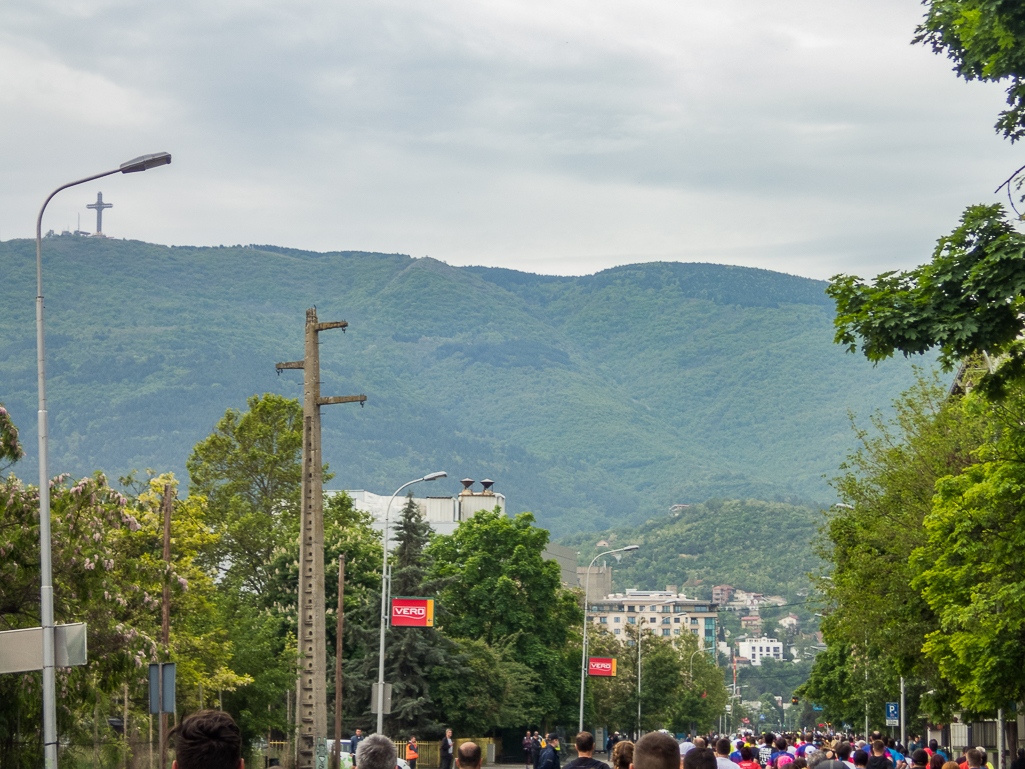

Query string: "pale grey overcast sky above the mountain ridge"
[[0, 0, 1021, 279]]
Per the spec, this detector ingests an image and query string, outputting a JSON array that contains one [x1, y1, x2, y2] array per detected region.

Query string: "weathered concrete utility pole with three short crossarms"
[[276, 308, 367, 769]]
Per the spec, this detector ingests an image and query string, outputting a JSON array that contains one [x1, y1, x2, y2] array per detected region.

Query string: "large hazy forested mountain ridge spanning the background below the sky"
[[0, 237, 930, 533]]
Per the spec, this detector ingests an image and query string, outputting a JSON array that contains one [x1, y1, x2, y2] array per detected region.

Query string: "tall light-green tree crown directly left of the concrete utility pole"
[[186, 393, 331, 595]]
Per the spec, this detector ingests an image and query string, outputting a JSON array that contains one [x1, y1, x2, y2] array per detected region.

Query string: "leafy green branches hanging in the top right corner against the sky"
[[914, 0, 1025, 141]]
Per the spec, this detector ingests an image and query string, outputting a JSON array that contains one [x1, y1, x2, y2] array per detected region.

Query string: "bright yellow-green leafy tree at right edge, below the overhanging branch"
[[912, 387, 1025, 713]]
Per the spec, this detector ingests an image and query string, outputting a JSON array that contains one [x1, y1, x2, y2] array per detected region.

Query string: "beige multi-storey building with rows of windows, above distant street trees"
[[587, 591, 719, 649]]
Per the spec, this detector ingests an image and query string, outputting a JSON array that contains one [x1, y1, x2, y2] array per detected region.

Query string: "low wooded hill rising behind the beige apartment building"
[[561, 499, 823, 598]]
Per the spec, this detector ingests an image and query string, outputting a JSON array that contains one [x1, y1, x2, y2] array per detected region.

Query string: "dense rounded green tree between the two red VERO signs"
[[427, 508, 583, 722]]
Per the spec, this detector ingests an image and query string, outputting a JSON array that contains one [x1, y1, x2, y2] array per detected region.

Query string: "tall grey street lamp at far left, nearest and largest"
[[36, 152, 171, 769]]
